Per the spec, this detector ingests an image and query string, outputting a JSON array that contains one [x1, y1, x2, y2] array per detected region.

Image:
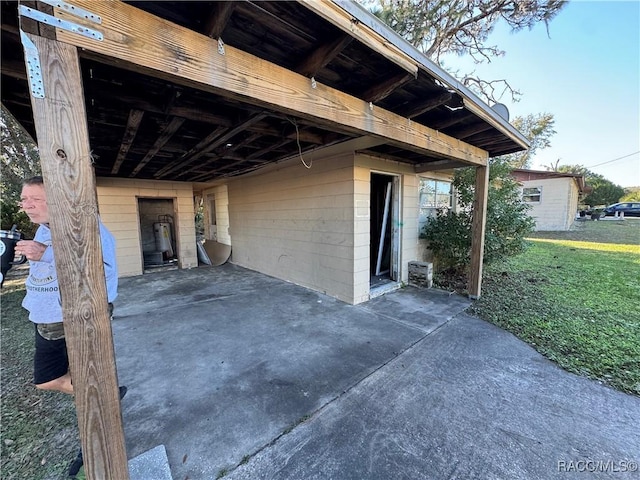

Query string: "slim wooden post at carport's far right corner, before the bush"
[[469, 163, 489, 299]]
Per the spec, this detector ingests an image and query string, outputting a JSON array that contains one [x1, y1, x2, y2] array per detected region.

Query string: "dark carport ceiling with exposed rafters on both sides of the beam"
[[1, 1, 522, 182]]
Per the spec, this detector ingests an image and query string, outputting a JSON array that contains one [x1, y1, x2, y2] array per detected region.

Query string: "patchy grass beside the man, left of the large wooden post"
[[0, 282, 80, 480]]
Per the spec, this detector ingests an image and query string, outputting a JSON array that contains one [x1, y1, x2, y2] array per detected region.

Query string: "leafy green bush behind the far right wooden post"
[[421, 157, 535, 270]]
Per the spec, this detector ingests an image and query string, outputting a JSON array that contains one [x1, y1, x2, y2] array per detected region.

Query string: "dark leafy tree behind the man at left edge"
[[0, 105, 40, 236]]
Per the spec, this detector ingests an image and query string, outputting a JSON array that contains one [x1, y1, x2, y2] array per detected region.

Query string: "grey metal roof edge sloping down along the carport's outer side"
[[332, 0, 530, 149]]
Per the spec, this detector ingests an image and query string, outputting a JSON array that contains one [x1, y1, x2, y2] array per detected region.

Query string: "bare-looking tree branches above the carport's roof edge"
[[369, 0, 566, 102]]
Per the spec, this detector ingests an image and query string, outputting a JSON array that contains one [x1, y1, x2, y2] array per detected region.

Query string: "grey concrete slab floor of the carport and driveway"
[[113, 264, 640, 480]]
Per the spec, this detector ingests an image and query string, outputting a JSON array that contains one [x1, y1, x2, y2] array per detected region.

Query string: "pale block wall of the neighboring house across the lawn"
[[521, 178, 578, 231]]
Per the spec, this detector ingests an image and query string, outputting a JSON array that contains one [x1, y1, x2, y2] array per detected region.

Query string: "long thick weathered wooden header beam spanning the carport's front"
[[55, 0, 487, 165]]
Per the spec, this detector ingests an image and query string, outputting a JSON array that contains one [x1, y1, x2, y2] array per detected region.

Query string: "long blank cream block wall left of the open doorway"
[[228, 155, 358, 303]]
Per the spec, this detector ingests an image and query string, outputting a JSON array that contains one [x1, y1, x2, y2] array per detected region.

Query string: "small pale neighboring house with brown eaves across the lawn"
[[512, 169, 588, 231]]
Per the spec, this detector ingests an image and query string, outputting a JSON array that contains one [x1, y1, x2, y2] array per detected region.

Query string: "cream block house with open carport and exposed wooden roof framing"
[[2, 0, 528, 304]]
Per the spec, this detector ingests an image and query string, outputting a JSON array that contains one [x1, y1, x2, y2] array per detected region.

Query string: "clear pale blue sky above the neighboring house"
[[444, 0, 640, 187]]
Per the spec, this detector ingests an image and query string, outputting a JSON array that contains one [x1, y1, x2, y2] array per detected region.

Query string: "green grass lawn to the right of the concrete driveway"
[[472, 219, 640, 395]]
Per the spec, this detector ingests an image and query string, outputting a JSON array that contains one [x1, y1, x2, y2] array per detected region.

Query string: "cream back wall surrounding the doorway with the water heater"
[[96, 177, 198, 277]]
